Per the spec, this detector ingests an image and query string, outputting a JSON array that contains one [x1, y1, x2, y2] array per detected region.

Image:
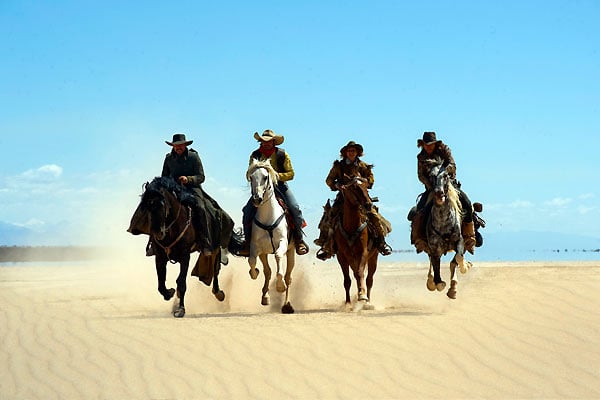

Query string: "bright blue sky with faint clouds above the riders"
[[0, 0, 600, 253]]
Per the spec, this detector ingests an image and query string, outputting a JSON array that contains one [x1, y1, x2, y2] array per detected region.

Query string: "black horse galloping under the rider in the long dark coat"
[[127, 177, 240, 318]]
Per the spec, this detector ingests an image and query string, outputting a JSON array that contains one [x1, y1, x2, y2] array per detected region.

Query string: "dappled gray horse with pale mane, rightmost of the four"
[[426, 160, 471, 299]]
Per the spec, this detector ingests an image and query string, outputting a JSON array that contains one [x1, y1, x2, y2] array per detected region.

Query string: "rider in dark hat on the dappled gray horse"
[[408, 132, 475, 254]]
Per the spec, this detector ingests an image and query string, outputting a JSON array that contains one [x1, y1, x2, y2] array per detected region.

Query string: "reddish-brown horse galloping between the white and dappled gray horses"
[[334, 176, 379, 310]]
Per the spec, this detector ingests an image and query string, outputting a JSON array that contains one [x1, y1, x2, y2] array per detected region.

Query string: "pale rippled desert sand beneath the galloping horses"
[[0, 254, 600, 399]]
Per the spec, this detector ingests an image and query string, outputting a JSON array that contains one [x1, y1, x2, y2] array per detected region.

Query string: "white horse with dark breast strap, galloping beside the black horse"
[[246, 161, 295, 314]]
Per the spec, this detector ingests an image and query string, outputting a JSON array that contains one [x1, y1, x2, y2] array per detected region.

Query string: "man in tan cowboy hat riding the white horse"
[[239, 129, 308, 256]]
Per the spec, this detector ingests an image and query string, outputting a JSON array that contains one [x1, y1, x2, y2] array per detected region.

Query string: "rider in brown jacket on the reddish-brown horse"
[[314, 141, 392, 260]]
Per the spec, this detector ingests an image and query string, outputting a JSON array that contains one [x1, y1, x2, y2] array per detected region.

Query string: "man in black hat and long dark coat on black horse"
[[161, 133, 233, 255]]
